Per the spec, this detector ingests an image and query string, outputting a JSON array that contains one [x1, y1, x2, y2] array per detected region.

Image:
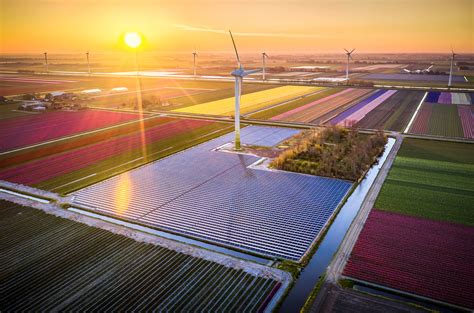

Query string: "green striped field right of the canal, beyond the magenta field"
[[375, 139, 474, 226]]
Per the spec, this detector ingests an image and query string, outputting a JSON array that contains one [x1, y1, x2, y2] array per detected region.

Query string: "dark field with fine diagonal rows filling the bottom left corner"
[[0, 201, 282, 312]]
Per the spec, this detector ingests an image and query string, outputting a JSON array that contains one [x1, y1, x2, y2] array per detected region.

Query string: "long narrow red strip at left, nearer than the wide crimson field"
[[0, 120, 211, 185]]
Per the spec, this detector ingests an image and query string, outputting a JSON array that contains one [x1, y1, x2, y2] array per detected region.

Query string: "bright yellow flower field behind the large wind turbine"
[[173, 86, 322, 115]]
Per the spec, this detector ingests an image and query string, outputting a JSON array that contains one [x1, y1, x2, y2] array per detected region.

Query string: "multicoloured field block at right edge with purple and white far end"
[[409, 92, 474, 139]]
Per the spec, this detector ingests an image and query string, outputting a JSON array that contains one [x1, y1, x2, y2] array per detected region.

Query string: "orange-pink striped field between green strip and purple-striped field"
[[272, 88, 372, 124]]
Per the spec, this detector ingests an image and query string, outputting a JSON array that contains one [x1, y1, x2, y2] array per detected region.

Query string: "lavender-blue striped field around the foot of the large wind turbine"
[[74, 126, 351, 260]]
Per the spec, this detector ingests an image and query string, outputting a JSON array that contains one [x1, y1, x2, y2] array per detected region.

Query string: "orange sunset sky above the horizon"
[[0, 0, 474, 53]]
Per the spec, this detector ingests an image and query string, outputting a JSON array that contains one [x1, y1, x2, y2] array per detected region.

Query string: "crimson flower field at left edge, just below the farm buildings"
[[0, 110, 139, 152]]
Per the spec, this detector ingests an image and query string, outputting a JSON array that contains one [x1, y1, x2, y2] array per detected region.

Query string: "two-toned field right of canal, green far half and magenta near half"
[[343, 138, 474, 309]]
